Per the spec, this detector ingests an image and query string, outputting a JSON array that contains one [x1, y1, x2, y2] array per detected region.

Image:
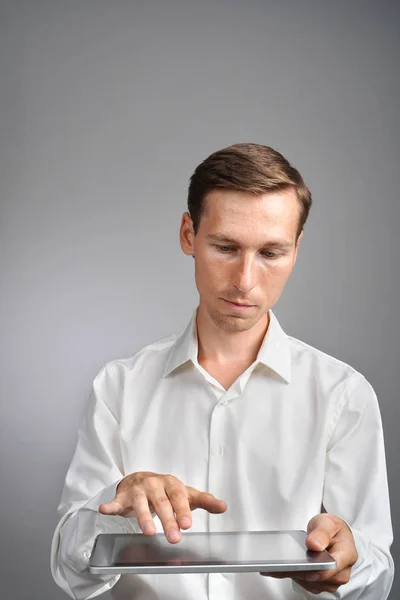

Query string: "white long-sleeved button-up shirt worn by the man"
[[51, 312, 393, 600]]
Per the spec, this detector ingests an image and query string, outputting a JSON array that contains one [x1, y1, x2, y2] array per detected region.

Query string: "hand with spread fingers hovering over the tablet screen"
[[99, 471, 227, 544]]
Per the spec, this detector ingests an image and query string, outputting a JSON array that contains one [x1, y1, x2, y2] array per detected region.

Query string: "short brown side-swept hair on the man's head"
[[188, 144, 312, 237]]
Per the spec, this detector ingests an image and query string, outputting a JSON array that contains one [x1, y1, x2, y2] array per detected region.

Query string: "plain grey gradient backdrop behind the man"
[[0, 0, 400, 600]]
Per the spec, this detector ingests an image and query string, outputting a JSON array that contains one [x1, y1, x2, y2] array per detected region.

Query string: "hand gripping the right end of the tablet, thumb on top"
[[261, 513, 358, 594]]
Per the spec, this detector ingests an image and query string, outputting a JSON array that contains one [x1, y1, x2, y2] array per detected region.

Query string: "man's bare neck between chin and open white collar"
[[196, 306, 270, 365]]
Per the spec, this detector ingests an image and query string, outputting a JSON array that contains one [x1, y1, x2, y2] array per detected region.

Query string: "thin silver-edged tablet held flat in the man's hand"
[[88, 530, 336, 574]]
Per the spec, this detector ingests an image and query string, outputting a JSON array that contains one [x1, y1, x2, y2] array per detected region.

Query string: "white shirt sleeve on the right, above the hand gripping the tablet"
[[293, 373, 394, 600]]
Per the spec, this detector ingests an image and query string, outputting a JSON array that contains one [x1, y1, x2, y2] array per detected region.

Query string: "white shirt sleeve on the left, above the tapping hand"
[[51, 367, 140, 600]]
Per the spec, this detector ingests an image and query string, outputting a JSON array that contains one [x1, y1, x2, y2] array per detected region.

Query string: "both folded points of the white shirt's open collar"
[[163, 310, 291, 383]]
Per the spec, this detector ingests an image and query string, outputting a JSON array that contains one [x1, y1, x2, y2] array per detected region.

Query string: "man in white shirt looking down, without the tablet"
[[52, 144, 393, 600]]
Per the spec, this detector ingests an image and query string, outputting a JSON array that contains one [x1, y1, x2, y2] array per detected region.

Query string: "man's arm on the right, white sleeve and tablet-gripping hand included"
[[262, 373, 394, 600]]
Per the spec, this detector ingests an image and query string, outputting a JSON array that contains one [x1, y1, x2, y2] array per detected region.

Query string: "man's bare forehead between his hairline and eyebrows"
[[200, 189, 300, 243]]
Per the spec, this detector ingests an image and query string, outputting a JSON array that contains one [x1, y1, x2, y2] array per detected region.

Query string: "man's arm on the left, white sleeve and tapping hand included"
[[51, 366, 226, 600]]
